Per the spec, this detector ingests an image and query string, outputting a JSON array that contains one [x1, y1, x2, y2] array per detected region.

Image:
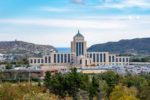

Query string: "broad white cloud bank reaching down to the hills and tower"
[[0, 16, 150, 47]]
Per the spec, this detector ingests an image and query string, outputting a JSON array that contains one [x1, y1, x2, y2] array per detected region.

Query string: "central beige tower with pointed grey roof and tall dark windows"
[[71, 30, 87, 57]]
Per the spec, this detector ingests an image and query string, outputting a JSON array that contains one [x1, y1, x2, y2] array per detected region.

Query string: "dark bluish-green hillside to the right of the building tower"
[[88, 38, 150, 55]]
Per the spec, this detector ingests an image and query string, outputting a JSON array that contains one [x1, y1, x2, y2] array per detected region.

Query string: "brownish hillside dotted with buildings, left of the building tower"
[[0, 41, 57, 55]]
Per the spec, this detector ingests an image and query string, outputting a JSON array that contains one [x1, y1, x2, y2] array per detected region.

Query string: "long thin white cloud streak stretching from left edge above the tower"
[[0, 19, 126, 29]]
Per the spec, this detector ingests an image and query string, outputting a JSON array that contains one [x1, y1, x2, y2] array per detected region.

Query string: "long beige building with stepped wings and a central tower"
[[29, 31, 129, 67]]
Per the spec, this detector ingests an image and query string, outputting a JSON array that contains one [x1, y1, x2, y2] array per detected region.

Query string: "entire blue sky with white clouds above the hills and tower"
[[0, 0, 150, 47]]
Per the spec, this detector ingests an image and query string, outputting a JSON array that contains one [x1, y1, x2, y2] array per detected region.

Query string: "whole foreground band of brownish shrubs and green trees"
[[0, 68, 150, 100]]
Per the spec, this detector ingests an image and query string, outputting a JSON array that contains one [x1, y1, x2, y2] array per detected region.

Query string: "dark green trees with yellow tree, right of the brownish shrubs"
[[44, 68, 150, 100]]
